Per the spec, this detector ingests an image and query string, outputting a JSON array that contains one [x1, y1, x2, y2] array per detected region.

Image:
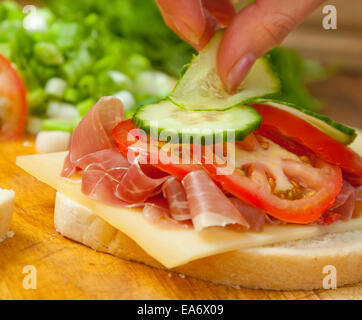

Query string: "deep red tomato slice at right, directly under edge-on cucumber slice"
[[253, 105, 362, 183]]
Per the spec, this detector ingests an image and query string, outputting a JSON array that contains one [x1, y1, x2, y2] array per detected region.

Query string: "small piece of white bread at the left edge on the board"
[[0, 188, 15, 242]]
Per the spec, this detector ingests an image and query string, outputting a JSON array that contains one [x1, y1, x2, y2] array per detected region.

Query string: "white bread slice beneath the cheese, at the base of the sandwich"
[[54, 192, 362, 290]]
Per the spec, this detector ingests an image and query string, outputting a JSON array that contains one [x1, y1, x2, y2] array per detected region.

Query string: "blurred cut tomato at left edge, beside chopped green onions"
[[0, 55, 26, 140]]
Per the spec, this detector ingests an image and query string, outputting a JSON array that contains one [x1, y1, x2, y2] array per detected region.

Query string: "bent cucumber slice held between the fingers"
[[169, 31, 280, 110]]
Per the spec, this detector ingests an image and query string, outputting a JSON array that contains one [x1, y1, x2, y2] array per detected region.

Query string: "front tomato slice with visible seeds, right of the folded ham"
[[204, 137, 342, 224]]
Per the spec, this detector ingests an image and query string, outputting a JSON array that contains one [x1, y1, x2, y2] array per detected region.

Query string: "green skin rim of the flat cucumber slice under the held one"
[[131, 100, 262, 145]]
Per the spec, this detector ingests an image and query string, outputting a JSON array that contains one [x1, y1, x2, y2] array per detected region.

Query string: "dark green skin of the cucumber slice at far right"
[[252, 98, 357, 145]]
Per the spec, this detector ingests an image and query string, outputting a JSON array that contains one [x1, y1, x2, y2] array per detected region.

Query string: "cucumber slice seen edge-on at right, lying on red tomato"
[[250, 98, 357, 145]]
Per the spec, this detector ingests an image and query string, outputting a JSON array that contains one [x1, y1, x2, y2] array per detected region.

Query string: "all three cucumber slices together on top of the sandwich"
[[132, 31, 356, 144]]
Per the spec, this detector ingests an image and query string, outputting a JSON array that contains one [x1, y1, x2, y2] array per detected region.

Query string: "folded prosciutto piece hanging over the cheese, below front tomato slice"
[[182, 170, 250, 231]]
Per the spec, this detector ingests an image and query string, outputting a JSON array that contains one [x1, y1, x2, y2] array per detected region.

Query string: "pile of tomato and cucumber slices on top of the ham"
[[113, 33, 362, 224]]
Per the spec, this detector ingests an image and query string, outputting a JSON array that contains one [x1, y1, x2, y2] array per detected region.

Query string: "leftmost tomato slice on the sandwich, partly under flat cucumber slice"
[[112, 120, 200, 179]]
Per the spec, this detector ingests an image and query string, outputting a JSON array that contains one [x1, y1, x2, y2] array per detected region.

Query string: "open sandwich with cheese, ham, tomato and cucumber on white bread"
[[17, 33, 362, 290]]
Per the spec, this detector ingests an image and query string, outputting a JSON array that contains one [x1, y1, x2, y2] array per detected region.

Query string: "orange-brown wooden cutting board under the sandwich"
[[0, 139, 362, 299]]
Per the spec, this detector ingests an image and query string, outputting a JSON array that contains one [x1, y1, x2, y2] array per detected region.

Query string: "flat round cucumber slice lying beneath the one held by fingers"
[[132, 100, 261, 144]]
